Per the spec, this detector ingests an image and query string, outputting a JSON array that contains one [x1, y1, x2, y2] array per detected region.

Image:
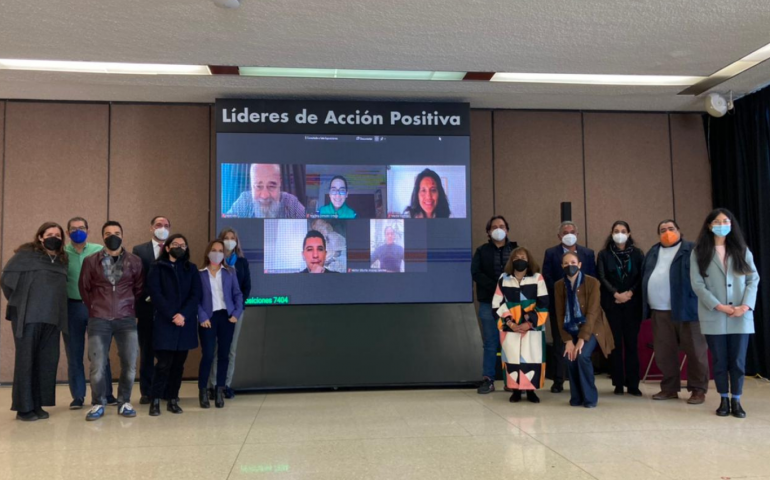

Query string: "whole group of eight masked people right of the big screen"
[[471, 208, 759, 418]]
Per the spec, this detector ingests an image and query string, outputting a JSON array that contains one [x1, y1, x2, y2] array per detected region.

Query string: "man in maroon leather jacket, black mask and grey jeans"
[[78, 221, 144, 421]]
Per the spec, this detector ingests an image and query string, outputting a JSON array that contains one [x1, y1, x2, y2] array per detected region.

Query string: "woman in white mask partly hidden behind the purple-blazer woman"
[[209, 227, 251, 400]]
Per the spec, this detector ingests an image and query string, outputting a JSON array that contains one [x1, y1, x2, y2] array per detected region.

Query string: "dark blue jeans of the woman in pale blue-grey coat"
[[706, 333, 749, 395]]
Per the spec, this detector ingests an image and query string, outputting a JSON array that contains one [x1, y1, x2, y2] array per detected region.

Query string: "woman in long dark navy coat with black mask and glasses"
[[147, 234, 201, 417]]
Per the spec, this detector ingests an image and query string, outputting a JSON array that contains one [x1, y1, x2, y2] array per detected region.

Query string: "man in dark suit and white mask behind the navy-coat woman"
[[131, 216, 171, 405]]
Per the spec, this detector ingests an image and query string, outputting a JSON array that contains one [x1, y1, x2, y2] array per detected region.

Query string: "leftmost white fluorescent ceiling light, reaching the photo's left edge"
[[0, 59, 211, 75]]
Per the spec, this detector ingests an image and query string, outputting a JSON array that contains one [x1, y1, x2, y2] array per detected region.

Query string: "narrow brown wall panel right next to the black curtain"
[[671, 114, 712, 241]]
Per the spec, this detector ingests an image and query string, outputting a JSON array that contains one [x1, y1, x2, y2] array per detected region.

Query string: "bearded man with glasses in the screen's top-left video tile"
[[227, 163, 305, 218]]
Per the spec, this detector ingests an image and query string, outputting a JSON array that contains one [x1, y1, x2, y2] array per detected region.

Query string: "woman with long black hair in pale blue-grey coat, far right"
[[690, 208, 759, 418]]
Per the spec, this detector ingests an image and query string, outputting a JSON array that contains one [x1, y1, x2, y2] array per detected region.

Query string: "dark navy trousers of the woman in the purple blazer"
[[198, 310, 235, 388]]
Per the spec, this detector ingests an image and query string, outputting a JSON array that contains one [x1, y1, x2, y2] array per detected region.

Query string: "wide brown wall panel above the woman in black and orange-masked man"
[[582, 113, 674, 252]]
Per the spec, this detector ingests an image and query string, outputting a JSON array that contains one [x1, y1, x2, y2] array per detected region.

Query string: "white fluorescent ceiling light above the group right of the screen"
[[491, 72, 705, 87]]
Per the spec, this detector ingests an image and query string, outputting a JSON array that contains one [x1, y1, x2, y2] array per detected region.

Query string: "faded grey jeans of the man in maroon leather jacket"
[[88, 317, 139, 405]]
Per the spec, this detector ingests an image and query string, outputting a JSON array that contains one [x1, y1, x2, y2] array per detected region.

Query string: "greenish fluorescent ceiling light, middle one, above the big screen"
[[240, 67, 465, 81]]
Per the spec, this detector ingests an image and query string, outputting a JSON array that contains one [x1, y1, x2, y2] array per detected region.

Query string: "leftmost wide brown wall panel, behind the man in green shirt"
[[0, 102, 109, 382]]
